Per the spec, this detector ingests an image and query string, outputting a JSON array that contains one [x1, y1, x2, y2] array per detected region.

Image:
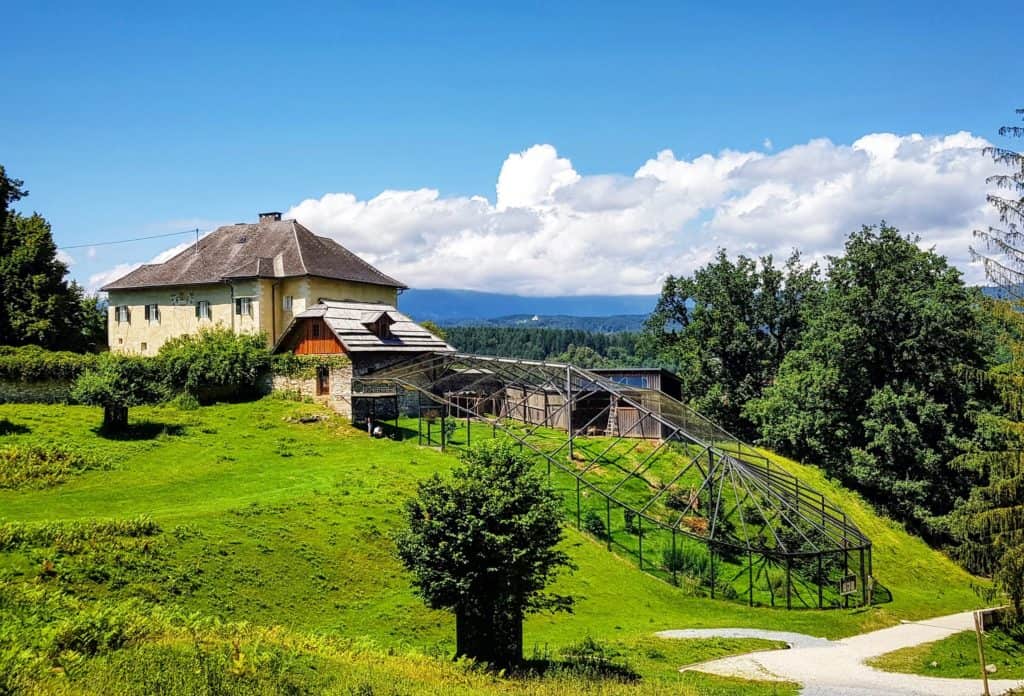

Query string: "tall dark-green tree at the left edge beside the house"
[[0, 166, 106, 352]]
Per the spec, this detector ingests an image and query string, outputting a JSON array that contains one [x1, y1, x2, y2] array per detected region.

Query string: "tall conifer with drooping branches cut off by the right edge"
[[954, 108, 1024, 624]]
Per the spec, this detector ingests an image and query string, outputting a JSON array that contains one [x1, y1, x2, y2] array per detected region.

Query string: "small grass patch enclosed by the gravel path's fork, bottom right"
[[868, 629, 1024, 679]]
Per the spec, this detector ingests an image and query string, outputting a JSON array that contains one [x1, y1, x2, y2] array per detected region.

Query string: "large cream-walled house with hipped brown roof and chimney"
[[102, 213, 406, 355]]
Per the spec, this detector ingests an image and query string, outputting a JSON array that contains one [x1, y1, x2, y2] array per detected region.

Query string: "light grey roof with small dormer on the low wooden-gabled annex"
[[278, 300, 455, 353]]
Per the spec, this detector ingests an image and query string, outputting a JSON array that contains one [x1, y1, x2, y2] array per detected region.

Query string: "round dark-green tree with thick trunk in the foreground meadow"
[[396, 441, 572, 667]]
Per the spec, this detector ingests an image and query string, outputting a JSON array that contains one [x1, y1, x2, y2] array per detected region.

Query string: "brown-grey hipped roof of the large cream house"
[[101, 220, 406, 291]]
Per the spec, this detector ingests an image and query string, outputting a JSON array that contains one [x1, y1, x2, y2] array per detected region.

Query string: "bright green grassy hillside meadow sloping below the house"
[[0, 397, 979, 694]]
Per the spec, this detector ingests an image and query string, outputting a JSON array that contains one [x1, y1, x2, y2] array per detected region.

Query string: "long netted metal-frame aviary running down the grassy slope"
[[353, 353, 876, 609]]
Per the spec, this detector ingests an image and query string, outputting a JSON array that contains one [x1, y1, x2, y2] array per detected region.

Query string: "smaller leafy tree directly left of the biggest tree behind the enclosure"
[[638, 251, 821, 436]]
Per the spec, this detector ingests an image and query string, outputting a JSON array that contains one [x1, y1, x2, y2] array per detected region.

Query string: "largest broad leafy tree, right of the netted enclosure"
[[745, 223, 983, 534]]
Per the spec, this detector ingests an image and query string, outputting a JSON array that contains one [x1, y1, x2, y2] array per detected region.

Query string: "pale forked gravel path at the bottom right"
[[657, 611, 1024, 696]]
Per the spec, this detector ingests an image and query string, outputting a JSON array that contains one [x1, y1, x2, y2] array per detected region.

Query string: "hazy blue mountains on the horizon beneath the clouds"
[[398, 290, 657, 332]]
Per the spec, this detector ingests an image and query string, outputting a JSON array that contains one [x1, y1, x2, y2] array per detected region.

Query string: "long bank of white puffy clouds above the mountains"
[[88, 132, 993, 295]]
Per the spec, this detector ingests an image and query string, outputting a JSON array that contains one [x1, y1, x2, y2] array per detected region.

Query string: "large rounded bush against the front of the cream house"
[[158, 329, 270, 402]]
